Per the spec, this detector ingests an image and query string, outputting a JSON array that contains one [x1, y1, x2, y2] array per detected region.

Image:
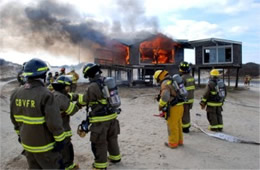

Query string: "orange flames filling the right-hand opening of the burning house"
[[139, 34, 178, 64]]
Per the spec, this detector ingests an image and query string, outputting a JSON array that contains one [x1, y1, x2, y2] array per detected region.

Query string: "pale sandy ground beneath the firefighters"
[[0, 82, 260, 169]]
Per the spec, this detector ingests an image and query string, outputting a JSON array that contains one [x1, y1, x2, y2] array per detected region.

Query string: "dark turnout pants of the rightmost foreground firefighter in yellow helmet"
[[207, 106, 223, 130]]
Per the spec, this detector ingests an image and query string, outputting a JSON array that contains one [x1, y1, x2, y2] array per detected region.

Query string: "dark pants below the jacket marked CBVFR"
[[25, 151, 65, 169]]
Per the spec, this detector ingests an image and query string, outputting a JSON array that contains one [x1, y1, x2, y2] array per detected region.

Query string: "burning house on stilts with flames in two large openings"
[[95, 34, 192, 85]]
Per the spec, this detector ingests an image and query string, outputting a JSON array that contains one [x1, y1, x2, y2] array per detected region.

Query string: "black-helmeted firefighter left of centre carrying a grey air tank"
[[78, 63, 121, 169]]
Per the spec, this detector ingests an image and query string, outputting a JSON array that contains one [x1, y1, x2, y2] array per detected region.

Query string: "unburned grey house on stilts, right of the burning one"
[[189, 38, 242, 88]]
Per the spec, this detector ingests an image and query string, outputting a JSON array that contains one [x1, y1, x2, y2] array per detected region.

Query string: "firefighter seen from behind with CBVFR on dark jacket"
[[10, 59, 65, 169]]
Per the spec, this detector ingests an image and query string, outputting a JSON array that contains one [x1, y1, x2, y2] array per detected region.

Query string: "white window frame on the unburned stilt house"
[[202, 45, 233, 65]]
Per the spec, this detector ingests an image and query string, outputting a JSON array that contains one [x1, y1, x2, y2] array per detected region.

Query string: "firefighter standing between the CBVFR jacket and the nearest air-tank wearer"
[[52, 75, 79, 169]]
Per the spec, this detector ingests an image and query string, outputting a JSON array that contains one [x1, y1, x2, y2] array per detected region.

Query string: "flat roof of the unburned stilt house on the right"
[[189, 38, 242, 47]]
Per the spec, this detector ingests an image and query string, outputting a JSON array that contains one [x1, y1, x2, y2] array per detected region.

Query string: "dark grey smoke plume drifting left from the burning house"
[[0, 0, 158, 60]]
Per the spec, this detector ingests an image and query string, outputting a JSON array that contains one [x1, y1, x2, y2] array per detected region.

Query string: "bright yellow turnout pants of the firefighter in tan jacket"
[[167, 105, 183, 147]]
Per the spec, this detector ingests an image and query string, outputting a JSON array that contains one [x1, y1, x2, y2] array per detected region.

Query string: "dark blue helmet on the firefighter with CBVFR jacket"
[[23, 58, 49, 78]]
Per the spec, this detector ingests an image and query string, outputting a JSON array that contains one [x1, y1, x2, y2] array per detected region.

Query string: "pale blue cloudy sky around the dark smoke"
[[0, 0, 260, 66]]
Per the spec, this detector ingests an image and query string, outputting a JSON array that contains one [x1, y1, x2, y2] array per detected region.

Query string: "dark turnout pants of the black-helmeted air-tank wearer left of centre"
[[90, 119, 121, 169]]
